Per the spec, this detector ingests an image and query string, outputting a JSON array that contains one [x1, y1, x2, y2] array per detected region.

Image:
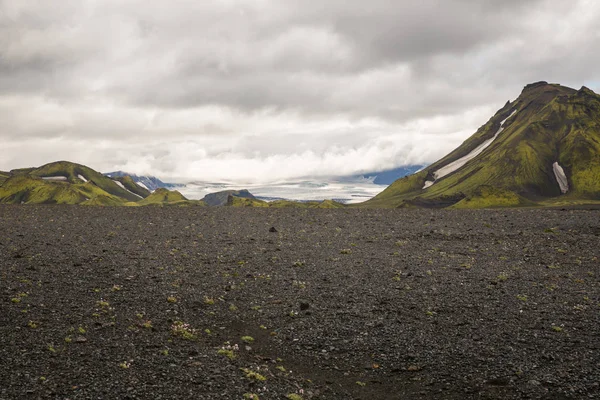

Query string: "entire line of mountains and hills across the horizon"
[[0, 82, 600, 208]]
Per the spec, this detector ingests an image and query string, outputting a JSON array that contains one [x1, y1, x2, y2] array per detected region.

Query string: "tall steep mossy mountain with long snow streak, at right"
[[362, 82, 600, 208]]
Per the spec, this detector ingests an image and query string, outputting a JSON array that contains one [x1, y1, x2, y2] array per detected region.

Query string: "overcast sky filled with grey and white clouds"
[[0, 0, 600, 182]]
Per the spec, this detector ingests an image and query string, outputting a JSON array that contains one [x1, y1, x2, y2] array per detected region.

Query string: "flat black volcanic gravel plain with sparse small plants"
[[0, 206, 600, 400]]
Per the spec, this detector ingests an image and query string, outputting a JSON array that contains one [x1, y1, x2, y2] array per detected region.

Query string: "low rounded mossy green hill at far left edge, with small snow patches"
[[0, 161, 190, 205]]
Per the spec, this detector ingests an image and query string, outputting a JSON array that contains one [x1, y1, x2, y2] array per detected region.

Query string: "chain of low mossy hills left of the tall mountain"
[[0, 161, 343, 208]]
